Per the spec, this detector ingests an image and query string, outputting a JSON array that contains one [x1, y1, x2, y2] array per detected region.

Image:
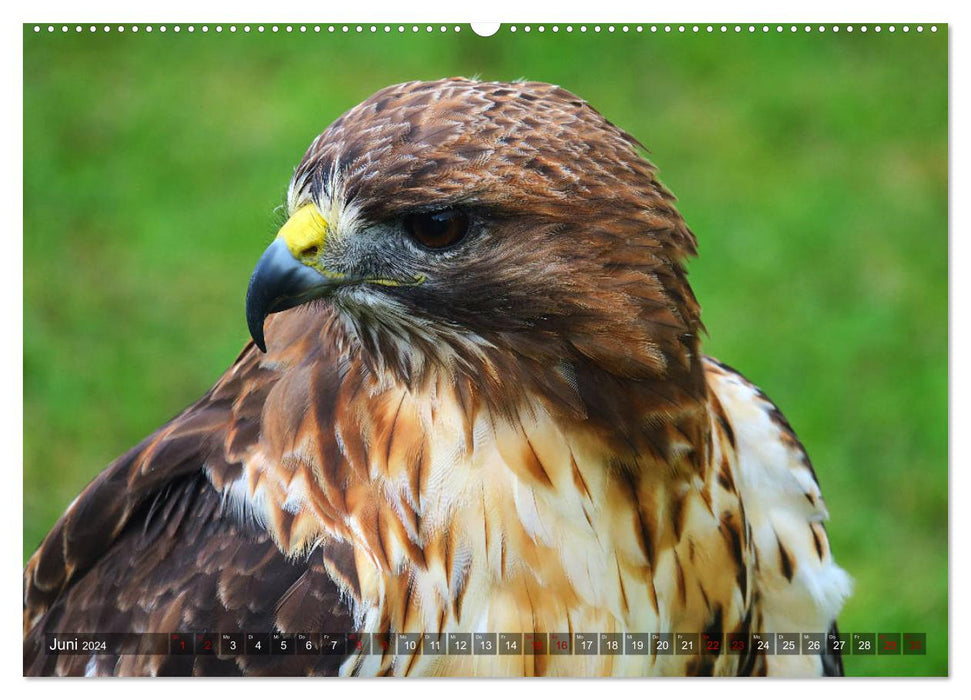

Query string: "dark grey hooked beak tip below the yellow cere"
[[246, 239, 333, 353]]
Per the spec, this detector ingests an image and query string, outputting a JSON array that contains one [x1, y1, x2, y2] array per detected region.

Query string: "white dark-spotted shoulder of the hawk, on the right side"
[[705, 357, 852, 675]]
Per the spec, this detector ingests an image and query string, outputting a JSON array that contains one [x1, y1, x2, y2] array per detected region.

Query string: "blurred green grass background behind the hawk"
[[23, 26, 948, 675]]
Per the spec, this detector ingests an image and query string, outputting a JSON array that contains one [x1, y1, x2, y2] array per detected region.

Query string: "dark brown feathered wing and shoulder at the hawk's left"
[[24, 345, 351, 676]]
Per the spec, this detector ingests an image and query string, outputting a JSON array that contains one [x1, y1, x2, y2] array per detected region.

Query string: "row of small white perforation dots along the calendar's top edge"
[[28, 24, 937, 34]]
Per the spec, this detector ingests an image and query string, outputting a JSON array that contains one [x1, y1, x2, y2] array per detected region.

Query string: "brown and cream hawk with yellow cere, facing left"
[[24, 78, 850, 676]]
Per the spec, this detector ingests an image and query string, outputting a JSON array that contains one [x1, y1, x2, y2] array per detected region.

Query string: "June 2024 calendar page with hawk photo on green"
[[22, 22, 949, 678]]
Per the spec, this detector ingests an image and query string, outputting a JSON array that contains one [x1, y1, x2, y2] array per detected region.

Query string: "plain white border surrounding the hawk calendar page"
[[0, 0, 971, 700]]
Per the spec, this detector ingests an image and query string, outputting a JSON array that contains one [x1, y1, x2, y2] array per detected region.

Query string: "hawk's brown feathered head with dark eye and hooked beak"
[[246, 79, 703, 422]]
